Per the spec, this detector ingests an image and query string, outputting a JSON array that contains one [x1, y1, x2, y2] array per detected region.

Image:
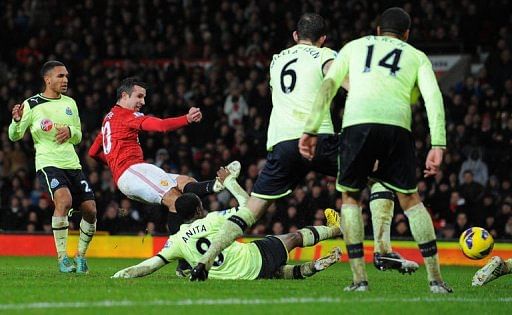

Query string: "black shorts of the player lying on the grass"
[[253, 236, 288, 279]]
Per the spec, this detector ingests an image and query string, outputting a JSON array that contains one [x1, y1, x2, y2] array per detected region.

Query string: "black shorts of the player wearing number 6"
[[252, 135, 339, 199]]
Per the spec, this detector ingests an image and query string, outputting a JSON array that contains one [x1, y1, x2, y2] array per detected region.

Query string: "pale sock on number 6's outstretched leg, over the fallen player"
[[199, 207, 256, 269]]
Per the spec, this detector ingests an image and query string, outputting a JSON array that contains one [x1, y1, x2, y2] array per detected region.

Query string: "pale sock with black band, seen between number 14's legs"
[[370, 183, 395, 254]]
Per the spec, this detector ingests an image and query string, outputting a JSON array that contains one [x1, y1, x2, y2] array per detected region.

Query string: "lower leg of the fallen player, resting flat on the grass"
[[274, 247, 341, 280]]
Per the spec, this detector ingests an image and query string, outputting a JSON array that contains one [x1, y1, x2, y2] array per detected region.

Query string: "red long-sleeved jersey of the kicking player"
[[89, 105, 188, 183]]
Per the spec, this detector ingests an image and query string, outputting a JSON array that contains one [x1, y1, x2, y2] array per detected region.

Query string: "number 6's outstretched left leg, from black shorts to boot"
[[190, 140, 303, 281]]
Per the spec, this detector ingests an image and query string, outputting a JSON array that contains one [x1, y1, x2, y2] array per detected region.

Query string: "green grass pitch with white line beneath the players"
[[0, 257, 512, 315]]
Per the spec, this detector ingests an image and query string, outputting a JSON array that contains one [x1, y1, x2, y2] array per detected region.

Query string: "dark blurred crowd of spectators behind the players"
[[0, 0, 512, 239]]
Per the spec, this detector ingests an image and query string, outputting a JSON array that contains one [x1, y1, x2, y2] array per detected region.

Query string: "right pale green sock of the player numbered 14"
[[404, 202, 442, 282]]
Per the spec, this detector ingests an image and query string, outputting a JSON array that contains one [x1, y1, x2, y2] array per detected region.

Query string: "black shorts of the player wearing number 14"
[[336, 124, 417, 193]]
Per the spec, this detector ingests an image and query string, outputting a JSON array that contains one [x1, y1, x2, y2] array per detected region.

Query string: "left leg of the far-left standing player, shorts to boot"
[[38, 167, 76, 272]]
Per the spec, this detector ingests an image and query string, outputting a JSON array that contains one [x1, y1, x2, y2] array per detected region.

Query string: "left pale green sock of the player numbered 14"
[[341, 204, 368, 283]]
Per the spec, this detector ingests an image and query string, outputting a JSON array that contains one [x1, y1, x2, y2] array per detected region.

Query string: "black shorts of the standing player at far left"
[[37, 166, 94, 208]]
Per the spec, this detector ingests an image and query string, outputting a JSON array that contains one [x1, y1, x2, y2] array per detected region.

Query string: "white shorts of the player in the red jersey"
[[117, 163, 179, 204]]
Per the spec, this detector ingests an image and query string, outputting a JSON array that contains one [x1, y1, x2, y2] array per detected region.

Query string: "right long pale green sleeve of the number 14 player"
[[418, 54, 446, 147]]
